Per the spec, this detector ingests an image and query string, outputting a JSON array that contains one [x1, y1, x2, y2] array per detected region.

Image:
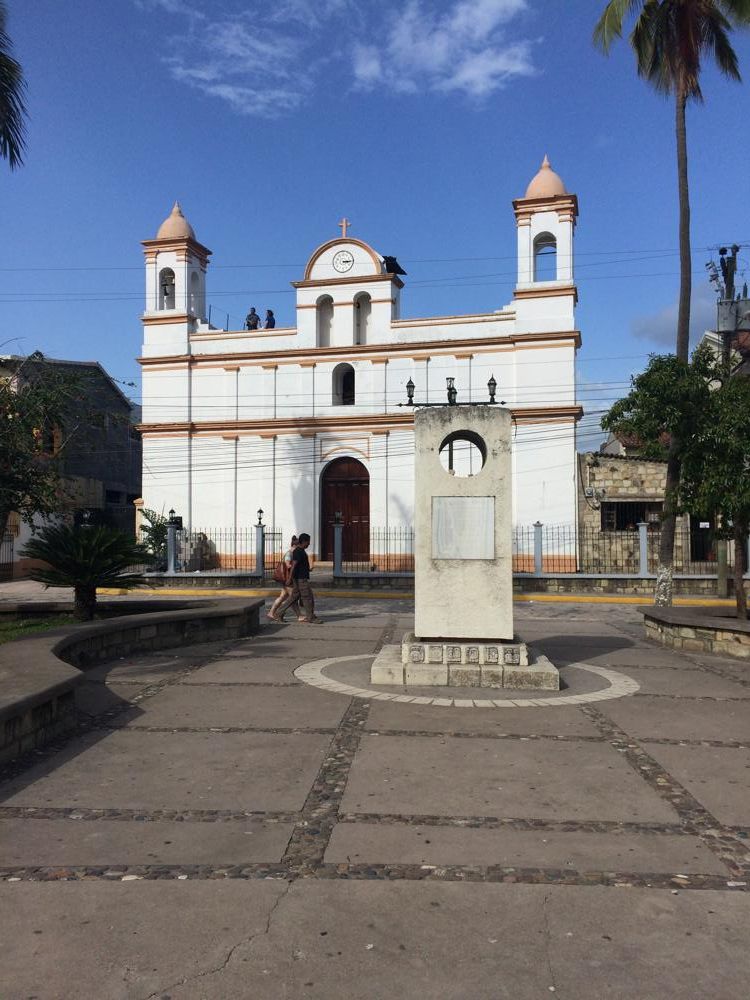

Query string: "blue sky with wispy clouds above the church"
[[0, 0, 750, 446]]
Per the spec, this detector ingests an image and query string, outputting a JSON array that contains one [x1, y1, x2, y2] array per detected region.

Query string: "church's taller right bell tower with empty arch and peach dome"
[[513, 156, 578, 332]]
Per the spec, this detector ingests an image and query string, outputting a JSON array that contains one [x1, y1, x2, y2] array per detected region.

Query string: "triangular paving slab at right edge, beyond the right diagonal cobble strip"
[[643, 742, 750, 826]]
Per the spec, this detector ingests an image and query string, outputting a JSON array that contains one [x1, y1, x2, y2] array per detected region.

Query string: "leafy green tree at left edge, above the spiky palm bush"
[[0, 354, 80, 537]]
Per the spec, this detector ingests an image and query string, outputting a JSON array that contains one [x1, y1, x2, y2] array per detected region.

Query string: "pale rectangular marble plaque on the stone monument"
[[432, 497, 495, 559]]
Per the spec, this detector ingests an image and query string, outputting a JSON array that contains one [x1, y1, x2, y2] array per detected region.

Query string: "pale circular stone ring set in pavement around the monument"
[[294, 653, 640, 708]]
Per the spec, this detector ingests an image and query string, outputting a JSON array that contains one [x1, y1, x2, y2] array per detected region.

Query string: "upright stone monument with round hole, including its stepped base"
[[370, 404, 560, 691]]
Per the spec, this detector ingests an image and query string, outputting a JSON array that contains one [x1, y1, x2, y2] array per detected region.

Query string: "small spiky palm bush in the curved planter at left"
[[21, 524, 152, 621]]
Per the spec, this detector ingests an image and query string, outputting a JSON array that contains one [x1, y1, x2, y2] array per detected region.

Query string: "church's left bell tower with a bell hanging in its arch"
[[143, 202, 211, 355]]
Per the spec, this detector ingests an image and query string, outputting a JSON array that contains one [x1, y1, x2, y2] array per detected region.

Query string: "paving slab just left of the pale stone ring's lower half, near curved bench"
[[134, 684, 349, 729]]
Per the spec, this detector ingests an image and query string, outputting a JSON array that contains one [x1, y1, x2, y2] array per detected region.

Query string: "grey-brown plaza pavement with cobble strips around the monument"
[[0, 598, 750, 1000]]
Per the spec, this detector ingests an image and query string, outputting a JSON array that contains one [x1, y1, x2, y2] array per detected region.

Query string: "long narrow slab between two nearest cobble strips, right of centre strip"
[[325, 823, 729, 877]]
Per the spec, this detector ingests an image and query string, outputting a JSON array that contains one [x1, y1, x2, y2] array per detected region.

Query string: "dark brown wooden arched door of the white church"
[[320, 457, 370, 562]]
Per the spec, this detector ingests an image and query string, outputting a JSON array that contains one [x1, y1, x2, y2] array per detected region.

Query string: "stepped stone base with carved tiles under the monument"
[[370, 633, 560, 691]]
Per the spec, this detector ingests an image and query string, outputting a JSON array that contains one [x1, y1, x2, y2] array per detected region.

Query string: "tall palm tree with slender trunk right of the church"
[[594, 0, 750, 605]]
